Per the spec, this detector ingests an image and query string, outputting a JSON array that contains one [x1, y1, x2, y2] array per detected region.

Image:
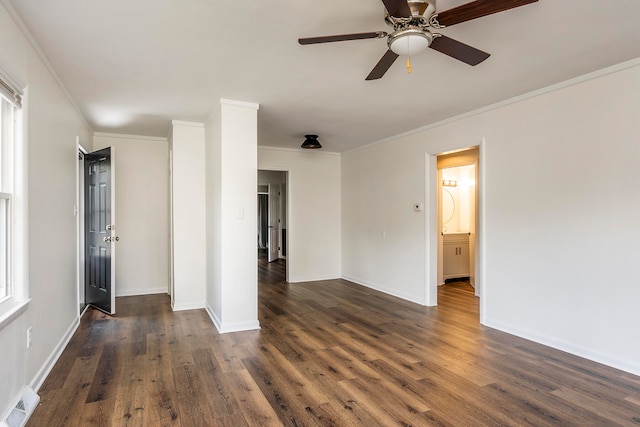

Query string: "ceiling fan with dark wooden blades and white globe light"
[[298, 0, 538, 80]]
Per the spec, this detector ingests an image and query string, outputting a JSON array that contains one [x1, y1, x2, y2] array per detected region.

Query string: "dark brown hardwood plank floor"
[[29, 260, 640, 426]]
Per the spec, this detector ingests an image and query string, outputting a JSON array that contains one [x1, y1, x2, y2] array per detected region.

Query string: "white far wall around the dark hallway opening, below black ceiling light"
[[258, 147, 341, 283]]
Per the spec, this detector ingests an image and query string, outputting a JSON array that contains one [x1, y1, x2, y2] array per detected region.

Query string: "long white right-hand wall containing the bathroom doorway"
[[342, 61, 640, 374]]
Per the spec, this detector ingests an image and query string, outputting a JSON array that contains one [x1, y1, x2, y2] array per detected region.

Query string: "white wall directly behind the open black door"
[[93, 134, 169, 296]]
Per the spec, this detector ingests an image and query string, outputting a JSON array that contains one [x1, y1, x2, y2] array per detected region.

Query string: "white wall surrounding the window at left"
[[0, 3, 92, 416]]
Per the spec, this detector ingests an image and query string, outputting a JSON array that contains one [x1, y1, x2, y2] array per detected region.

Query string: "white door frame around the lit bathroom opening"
[[425, 137, 488, 322]]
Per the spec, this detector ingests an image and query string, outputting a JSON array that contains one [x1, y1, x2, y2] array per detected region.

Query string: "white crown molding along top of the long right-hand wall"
[[343, 58, 640, 153]]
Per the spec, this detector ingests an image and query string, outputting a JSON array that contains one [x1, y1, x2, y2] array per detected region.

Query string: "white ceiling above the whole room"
[[5, 0, 640, 152]]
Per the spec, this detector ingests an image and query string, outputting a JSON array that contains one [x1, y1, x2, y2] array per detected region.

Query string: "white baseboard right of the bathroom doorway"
[[481, 317, 640, 375]]
